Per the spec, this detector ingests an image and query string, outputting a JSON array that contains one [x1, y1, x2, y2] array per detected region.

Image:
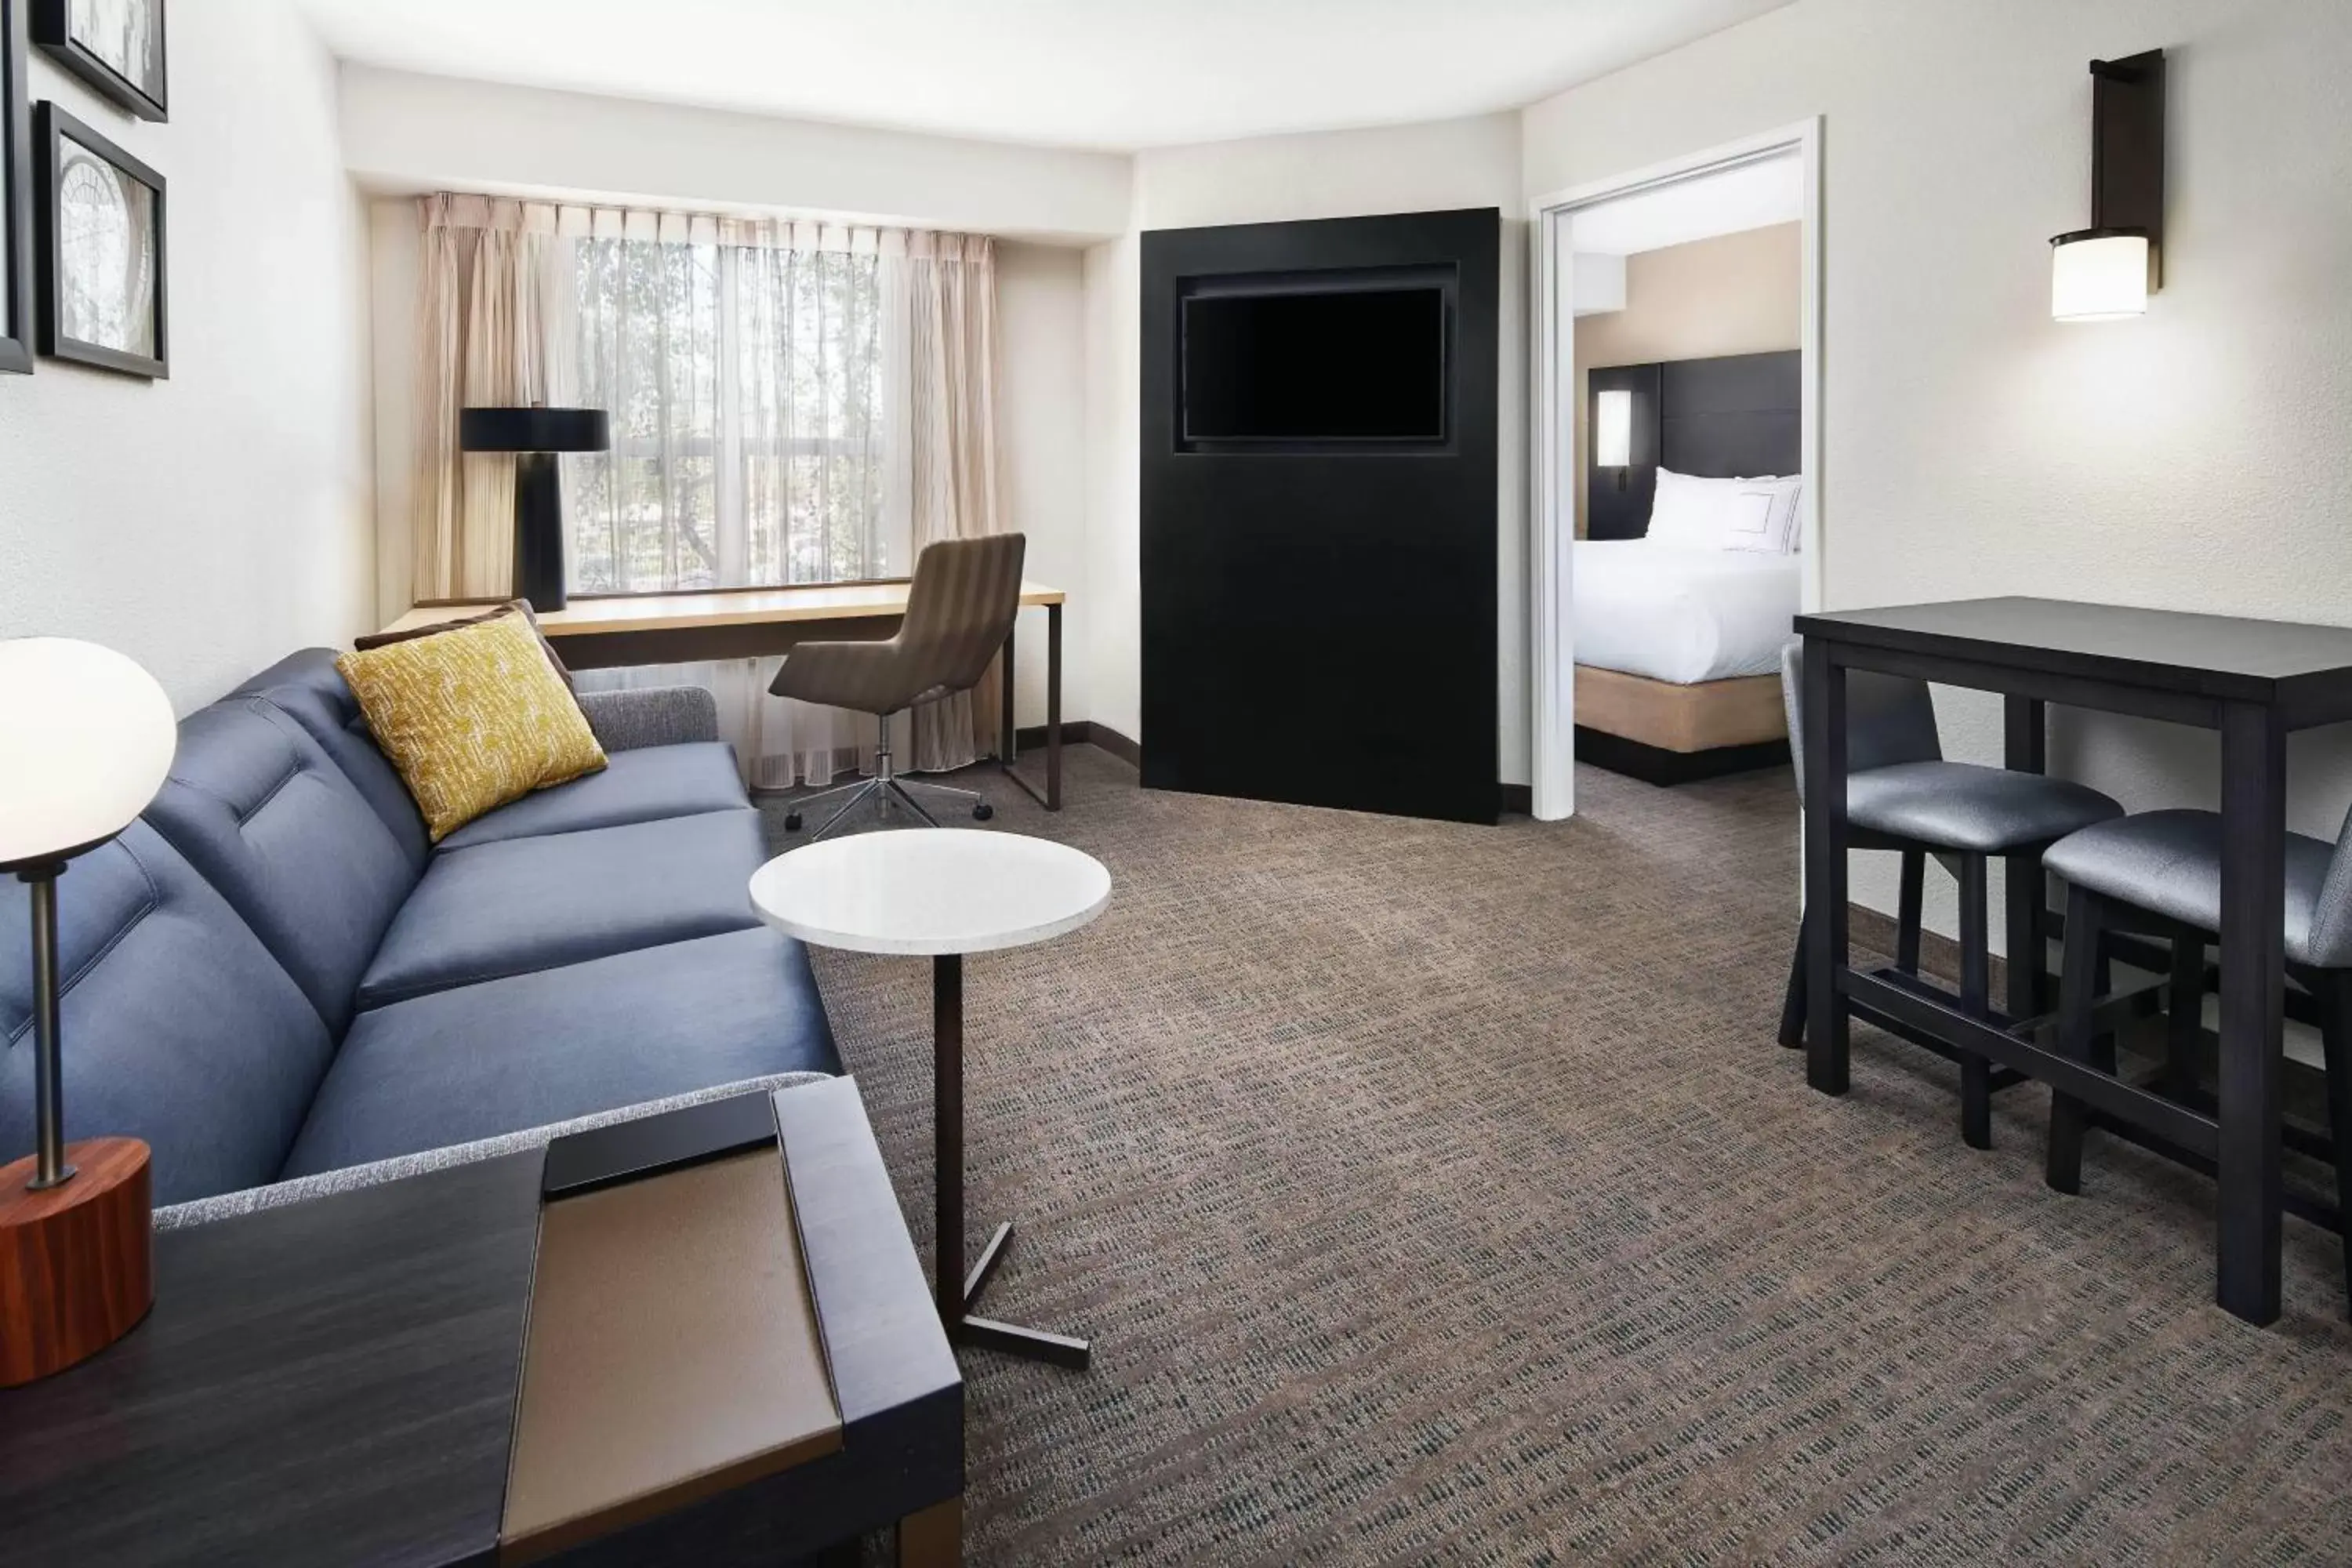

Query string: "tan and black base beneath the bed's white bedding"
[[1576, 666, 1790, 785]]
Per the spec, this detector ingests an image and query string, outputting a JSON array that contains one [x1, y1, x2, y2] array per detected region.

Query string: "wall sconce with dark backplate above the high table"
[[2051, 49, 2164, 322]]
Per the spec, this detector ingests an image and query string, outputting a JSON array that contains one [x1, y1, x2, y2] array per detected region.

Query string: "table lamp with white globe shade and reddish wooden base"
[[0, 637, 179, 1387]]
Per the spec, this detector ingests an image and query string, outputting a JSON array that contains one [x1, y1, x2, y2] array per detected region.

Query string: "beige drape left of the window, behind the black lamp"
[[412, 195, 562, 600]]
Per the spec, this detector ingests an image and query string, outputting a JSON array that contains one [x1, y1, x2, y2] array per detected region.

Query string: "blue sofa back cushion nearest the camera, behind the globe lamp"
[[0, 822, 334, 1203]]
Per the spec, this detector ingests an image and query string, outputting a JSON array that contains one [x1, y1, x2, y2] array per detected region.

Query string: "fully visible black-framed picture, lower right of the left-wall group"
[[33, 103, 172, 381]]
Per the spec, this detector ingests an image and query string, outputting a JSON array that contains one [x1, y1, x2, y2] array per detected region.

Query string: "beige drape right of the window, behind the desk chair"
[[901, 235, 1004, 771]]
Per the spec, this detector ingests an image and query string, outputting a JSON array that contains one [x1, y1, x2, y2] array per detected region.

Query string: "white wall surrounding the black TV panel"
[[1087, 113, 1529, 783]]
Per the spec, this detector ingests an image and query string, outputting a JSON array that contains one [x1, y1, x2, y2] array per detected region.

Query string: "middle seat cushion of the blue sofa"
[[360, 808, 767, 1008]]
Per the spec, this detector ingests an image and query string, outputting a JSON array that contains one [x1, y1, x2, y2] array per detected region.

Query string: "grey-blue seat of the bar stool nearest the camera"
[[2042, 811, 2352, 968]]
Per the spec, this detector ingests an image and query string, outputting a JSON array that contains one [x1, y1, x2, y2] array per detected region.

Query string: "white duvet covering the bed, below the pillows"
[[1569, 539, 1804, 687]]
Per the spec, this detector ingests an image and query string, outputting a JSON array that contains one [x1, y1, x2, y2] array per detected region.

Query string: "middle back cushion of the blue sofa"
[[146, 699, 416, 1032]]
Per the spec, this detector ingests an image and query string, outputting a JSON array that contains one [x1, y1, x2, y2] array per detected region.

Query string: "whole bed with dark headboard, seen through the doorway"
[[1569, 350, 1802, 785]]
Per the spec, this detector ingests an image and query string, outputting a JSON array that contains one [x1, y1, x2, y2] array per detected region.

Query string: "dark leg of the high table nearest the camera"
[[2218, 703, 2286, 1326]]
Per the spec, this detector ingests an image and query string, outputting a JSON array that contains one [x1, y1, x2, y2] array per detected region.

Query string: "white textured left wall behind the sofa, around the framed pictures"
[[0, 0, 374, 713]]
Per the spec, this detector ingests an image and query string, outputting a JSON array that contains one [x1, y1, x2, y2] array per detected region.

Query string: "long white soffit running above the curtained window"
[[341, 66, 1127, 242]]
